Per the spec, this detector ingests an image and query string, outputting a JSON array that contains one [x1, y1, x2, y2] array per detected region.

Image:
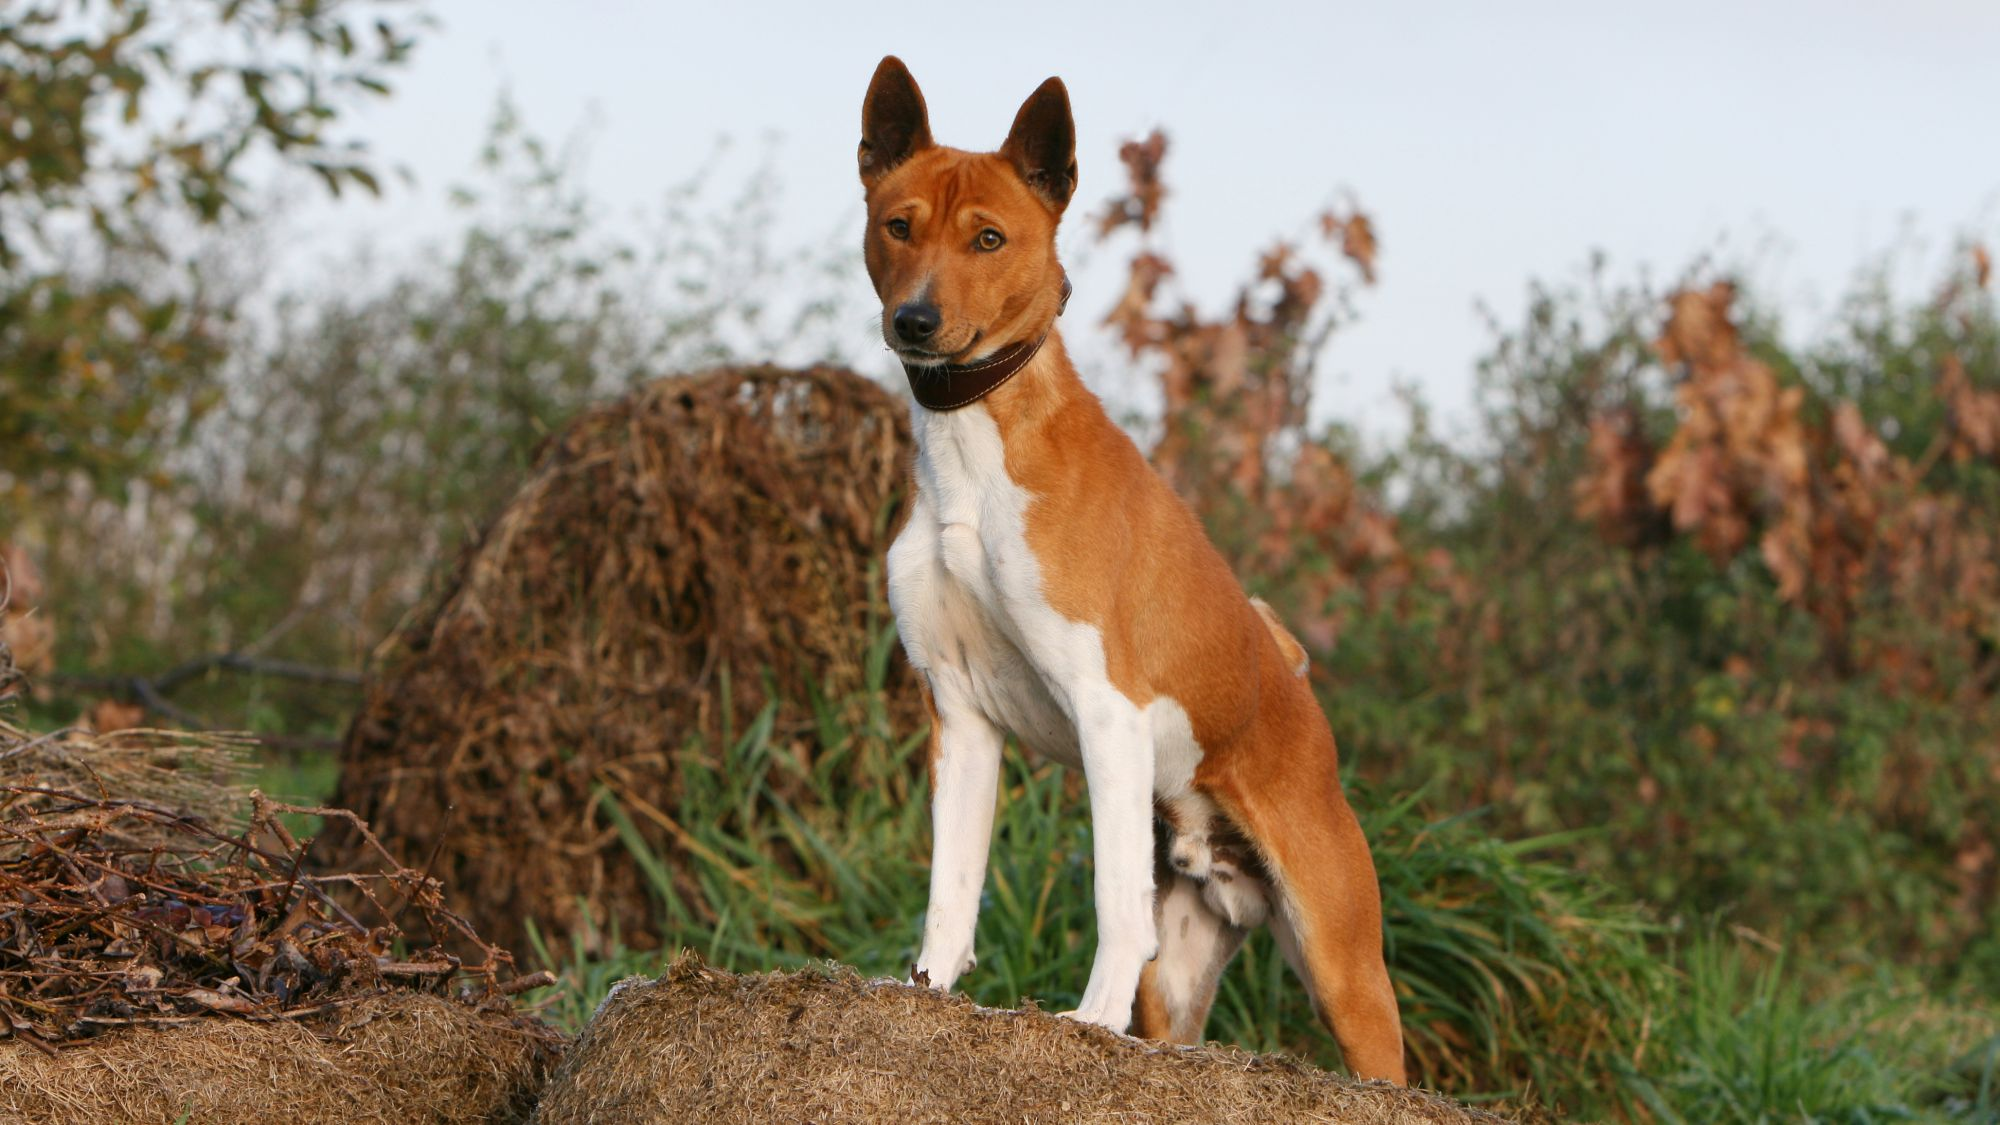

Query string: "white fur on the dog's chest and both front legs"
[[888, 404, 1202, 1031]]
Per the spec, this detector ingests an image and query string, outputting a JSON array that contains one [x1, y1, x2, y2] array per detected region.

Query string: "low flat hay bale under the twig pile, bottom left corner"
[[0, 993, 558, 1125]]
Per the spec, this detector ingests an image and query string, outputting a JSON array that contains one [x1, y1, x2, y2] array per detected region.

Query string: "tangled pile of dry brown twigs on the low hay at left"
[[0, 725, 550, 1049]]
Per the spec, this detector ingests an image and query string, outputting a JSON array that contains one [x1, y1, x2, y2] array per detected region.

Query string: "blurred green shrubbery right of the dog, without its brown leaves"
[[1312, 260, 2000, 991]]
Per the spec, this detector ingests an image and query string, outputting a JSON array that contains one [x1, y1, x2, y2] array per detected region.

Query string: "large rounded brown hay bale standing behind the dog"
[[316, 368, 920, 947]]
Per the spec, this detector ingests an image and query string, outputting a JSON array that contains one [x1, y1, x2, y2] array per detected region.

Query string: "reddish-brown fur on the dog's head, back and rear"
[[862, 60, 1404, 1083]]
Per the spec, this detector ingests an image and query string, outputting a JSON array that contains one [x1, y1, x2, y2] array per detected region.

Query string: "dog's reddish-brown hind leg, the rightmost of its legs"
[[1214, 755, 1404, 1083]]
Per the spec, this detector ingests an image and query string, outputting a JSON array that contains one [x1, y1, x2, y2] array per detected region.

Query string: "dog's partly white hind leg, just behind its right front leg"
[[1132, 867, 1244, 1043]]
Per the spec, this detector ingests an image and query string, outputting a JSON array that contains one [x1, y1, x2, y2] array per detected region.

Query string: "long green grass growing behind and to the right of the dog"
[[504, 656, 2000, 1125]]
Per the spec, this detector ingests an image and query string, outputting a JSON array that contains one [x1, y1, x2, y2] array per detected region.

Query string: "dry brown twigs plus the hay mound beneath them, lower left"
[[0, 704, 562, 1125]]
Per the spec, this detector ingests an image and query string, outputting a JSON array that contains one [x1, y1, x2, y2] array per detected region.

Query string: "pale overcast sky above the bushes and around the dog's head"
[[296, 0, 2000, 438]]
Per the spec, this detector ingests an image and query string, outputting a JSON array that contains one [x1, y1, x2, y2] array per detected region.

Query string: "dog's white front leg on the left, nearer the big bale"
[[916, 685, 1004, 991]]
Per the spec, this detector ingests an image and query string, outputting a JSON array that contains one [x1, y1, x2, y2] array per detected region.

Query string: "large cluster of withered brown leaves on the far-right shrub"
[[1574, 274, 2000, 645]]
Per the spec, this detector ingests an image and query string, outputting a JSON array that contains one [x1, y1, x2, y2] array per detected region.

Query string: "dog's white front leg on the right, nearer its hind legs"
[[1064, 687, 1160, 1031]]
